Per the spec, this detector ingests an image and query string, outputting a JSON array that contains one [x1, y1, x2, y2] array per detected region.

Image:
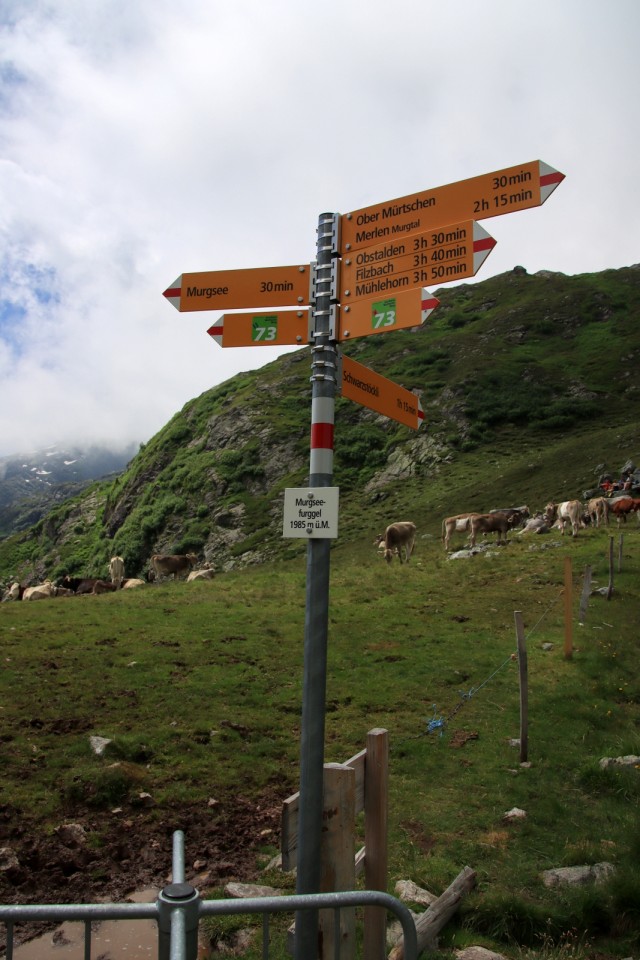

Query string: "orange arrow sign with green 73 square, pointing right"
[[336, 287, 440, 340]]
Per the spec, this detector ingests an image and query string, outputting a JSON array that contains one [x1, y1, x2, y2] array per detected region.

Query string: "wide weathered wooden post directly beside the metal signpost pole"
[[320, 763, 356, 960]]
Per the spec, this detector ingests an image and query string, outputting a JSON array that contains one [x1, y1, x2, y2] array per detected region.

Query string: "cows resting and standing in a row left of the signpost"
[[2, 553, 214, 601]]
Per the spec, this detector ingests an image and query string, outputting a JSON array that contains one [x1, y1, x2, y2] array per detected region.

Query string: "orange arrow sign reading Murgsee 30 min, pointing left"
[[164, 264, 310, 313]]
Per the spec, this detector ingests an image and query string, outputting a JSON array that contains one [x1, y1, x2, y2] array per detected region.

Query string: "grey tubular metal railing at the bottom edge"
[[0, 830, 417, 960]]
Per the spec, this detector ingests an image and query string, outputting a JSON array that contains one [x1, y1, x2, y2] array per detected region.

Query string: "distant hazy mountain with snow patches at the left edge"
[[0, 443, 139, 537]]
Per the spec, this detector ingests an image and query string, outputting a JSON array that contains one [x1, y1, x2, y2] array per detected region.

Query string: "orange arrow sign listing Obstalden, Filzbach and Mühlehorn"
[[340, 220, 496, 304]]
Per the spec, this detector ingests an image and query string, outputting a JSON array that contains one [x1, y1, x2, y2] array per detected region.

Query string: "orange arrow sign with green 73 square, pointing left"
[[207, 308, 309, 347]]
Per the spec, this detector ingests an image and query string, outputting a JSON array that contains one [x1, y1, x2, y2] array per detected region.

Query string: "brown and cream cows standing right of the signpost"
[[374, 496, 640, 563]]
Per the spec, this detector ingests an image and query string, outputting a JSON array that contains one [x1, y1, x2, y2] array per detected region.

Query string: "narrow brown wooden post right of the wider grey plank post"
[[363, 729, 389, 960]]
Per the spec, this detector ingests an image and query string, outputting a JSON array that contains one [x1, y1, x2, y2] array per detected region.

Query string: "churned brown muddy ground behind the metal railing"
[[0, 788, 290, 951]]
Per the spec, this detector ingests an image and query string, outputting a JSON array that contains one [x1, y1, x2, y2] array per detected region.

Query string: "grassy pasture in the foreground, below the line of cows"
[[0, 512, 640, 958]]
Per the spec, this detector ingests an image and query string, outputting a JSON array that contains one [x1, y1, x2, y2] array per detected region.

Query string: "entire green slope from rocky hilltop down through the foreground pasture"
[[0, 268, 640, 960]]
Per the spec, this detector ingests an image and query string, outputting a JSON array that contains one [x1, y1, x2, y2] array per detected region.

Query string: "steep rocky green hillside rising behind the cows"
[[0, 267, 640, 582]]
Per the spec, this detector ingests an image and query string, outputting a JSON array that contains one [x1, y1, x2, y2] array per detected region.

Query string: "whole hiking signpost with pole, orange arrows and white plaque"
[[164, 160, 564, 960]]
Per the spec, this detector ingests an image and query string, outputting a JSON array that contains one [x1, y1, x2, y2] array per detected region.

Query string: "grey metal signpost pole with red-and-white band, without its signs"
[[295, 213, 338, 960]]
